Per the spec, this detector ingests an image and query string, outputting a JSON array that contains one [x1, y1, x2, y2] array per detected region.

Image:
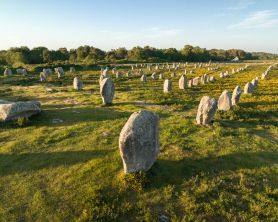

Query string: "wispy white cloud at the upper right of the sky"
[[228, 10, 278, 29]]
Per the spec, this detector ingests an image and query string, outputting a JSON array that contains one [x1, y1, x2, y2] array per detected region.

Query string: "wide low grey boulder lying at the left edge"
[[0, 100, 41, 121]]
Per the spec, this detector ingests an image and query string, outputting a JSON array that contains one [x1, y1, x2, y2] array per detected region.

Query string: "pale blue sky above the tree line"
[[0, 0, 278, 54]]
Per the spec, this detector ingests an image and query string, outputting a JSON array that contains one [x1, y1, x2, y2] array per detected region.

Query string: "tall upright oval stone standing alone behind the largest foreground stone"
[[100, 78, 115, 105]]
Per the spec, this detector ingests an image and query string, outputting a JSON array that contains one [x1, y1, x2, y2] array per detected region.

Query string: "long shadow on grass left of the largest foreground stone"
[[0, 150, 113, 176]]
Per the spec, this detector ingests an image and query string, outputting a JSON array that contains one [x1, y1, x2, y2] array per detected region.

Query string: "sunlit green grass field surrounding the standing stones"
[[0, 63, 278, 222]]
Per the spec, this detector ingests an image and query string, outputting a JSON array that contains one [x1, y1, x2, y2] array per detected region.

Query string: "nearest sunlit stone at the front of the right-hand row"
[[196, 96, 217, 125]]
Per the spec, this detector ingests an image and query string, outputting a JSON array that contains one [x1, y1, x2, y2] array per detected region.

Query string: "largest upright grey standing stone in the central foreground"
[[119, 111, 159, 173]]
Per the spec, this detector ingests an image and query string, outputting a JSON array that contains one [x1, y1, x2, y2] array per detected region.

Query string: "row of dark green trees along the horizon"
[[0, 45, 277, 66]]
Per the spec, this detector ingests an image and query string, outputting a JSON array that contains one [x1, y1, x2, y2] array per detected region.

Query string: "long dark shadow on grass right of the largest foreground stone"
[[147, 152, 278, 188]]
